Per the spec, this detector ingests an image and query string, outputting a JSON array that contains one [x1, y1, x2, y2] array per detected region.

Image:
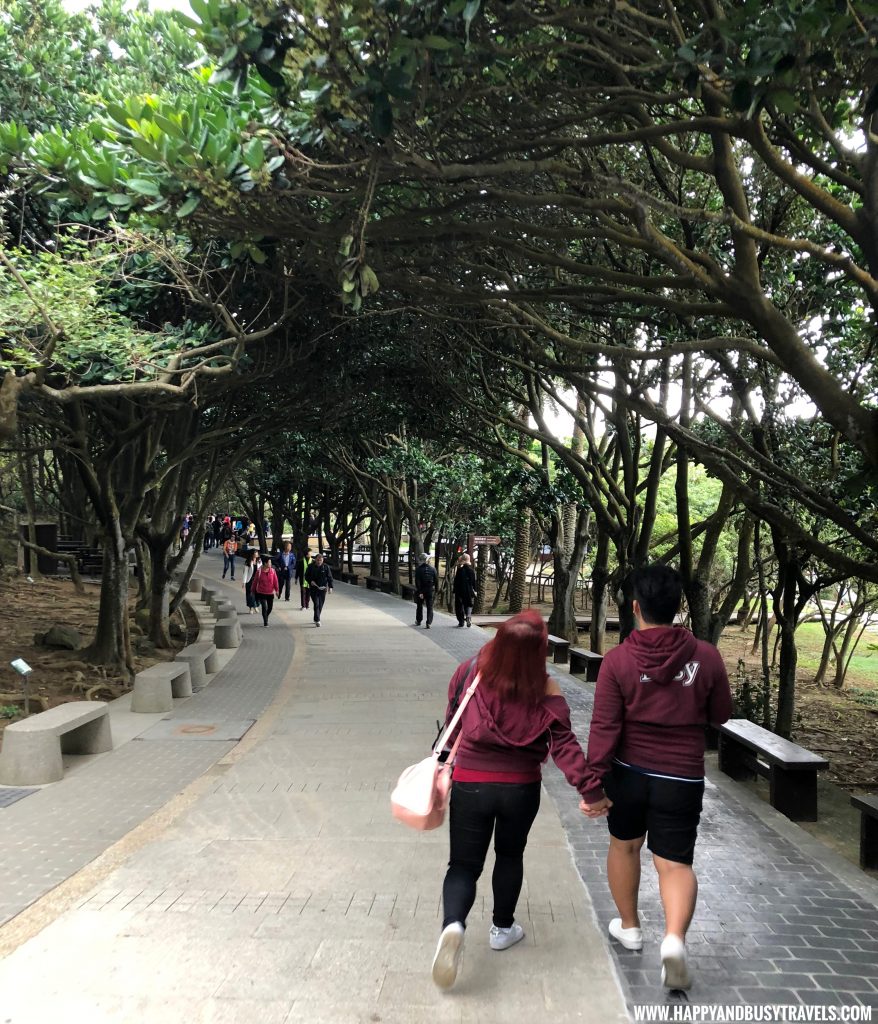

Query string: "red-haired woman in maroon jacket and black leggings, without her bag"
[[432, 610, 588, 988]]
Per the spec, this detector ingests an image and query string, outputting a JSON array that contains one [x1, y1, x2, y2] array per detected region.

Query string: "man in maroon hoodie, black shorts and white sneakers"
[[580, 565, 731, 988]]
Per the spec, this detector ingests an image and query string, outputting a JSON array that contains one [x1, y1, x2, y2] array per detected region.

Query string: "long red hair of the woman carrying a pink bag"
[[478, 610, 548, 703]]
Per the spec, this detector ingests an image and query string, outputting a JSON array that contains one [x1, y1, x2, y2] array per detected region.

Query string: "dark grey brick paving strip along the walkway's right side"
[[340, 587, 878, 1009]]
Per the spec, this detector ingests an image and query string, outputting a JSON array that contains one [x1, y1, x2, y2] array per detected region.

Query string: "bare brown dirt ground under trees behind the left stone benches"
[[0, 574, 184, 730]]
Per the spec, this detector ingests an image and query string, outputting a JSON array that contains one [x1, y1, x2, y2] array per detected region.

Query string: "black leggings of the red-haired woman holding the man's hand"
[[443, 782, 541, 928]]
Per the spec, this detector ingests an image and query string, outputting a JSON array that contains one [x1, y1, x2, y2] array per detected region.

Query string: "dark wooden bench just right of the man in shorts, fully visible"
[[719, 718, 829, 821]]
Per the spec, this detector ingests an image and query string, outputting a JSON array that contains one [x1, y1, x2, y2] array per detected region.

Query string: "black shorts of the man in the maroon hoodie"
[[603, 764, 704, 864]]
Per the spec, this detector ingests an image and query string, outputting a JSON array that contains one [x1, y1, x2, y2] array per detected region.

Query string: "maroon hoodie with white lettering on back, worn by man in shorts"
[[584, 626, 731, 804]]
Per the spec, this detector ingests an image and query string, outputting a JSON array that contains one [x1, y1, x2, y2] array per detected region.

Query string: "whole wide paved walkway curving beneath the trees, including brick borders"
[[0, 558, 878, 1024]]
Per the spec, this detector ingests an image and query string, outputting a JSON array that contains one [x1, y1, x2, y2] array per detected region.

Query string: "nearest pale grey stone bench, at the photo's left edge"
[[0, 700, 113, 785]]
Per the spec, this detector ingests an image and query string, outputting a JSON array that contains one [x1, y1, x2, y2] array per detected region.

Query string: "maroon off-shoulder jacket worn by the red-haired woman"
[[446, 658, 587, 792]]
